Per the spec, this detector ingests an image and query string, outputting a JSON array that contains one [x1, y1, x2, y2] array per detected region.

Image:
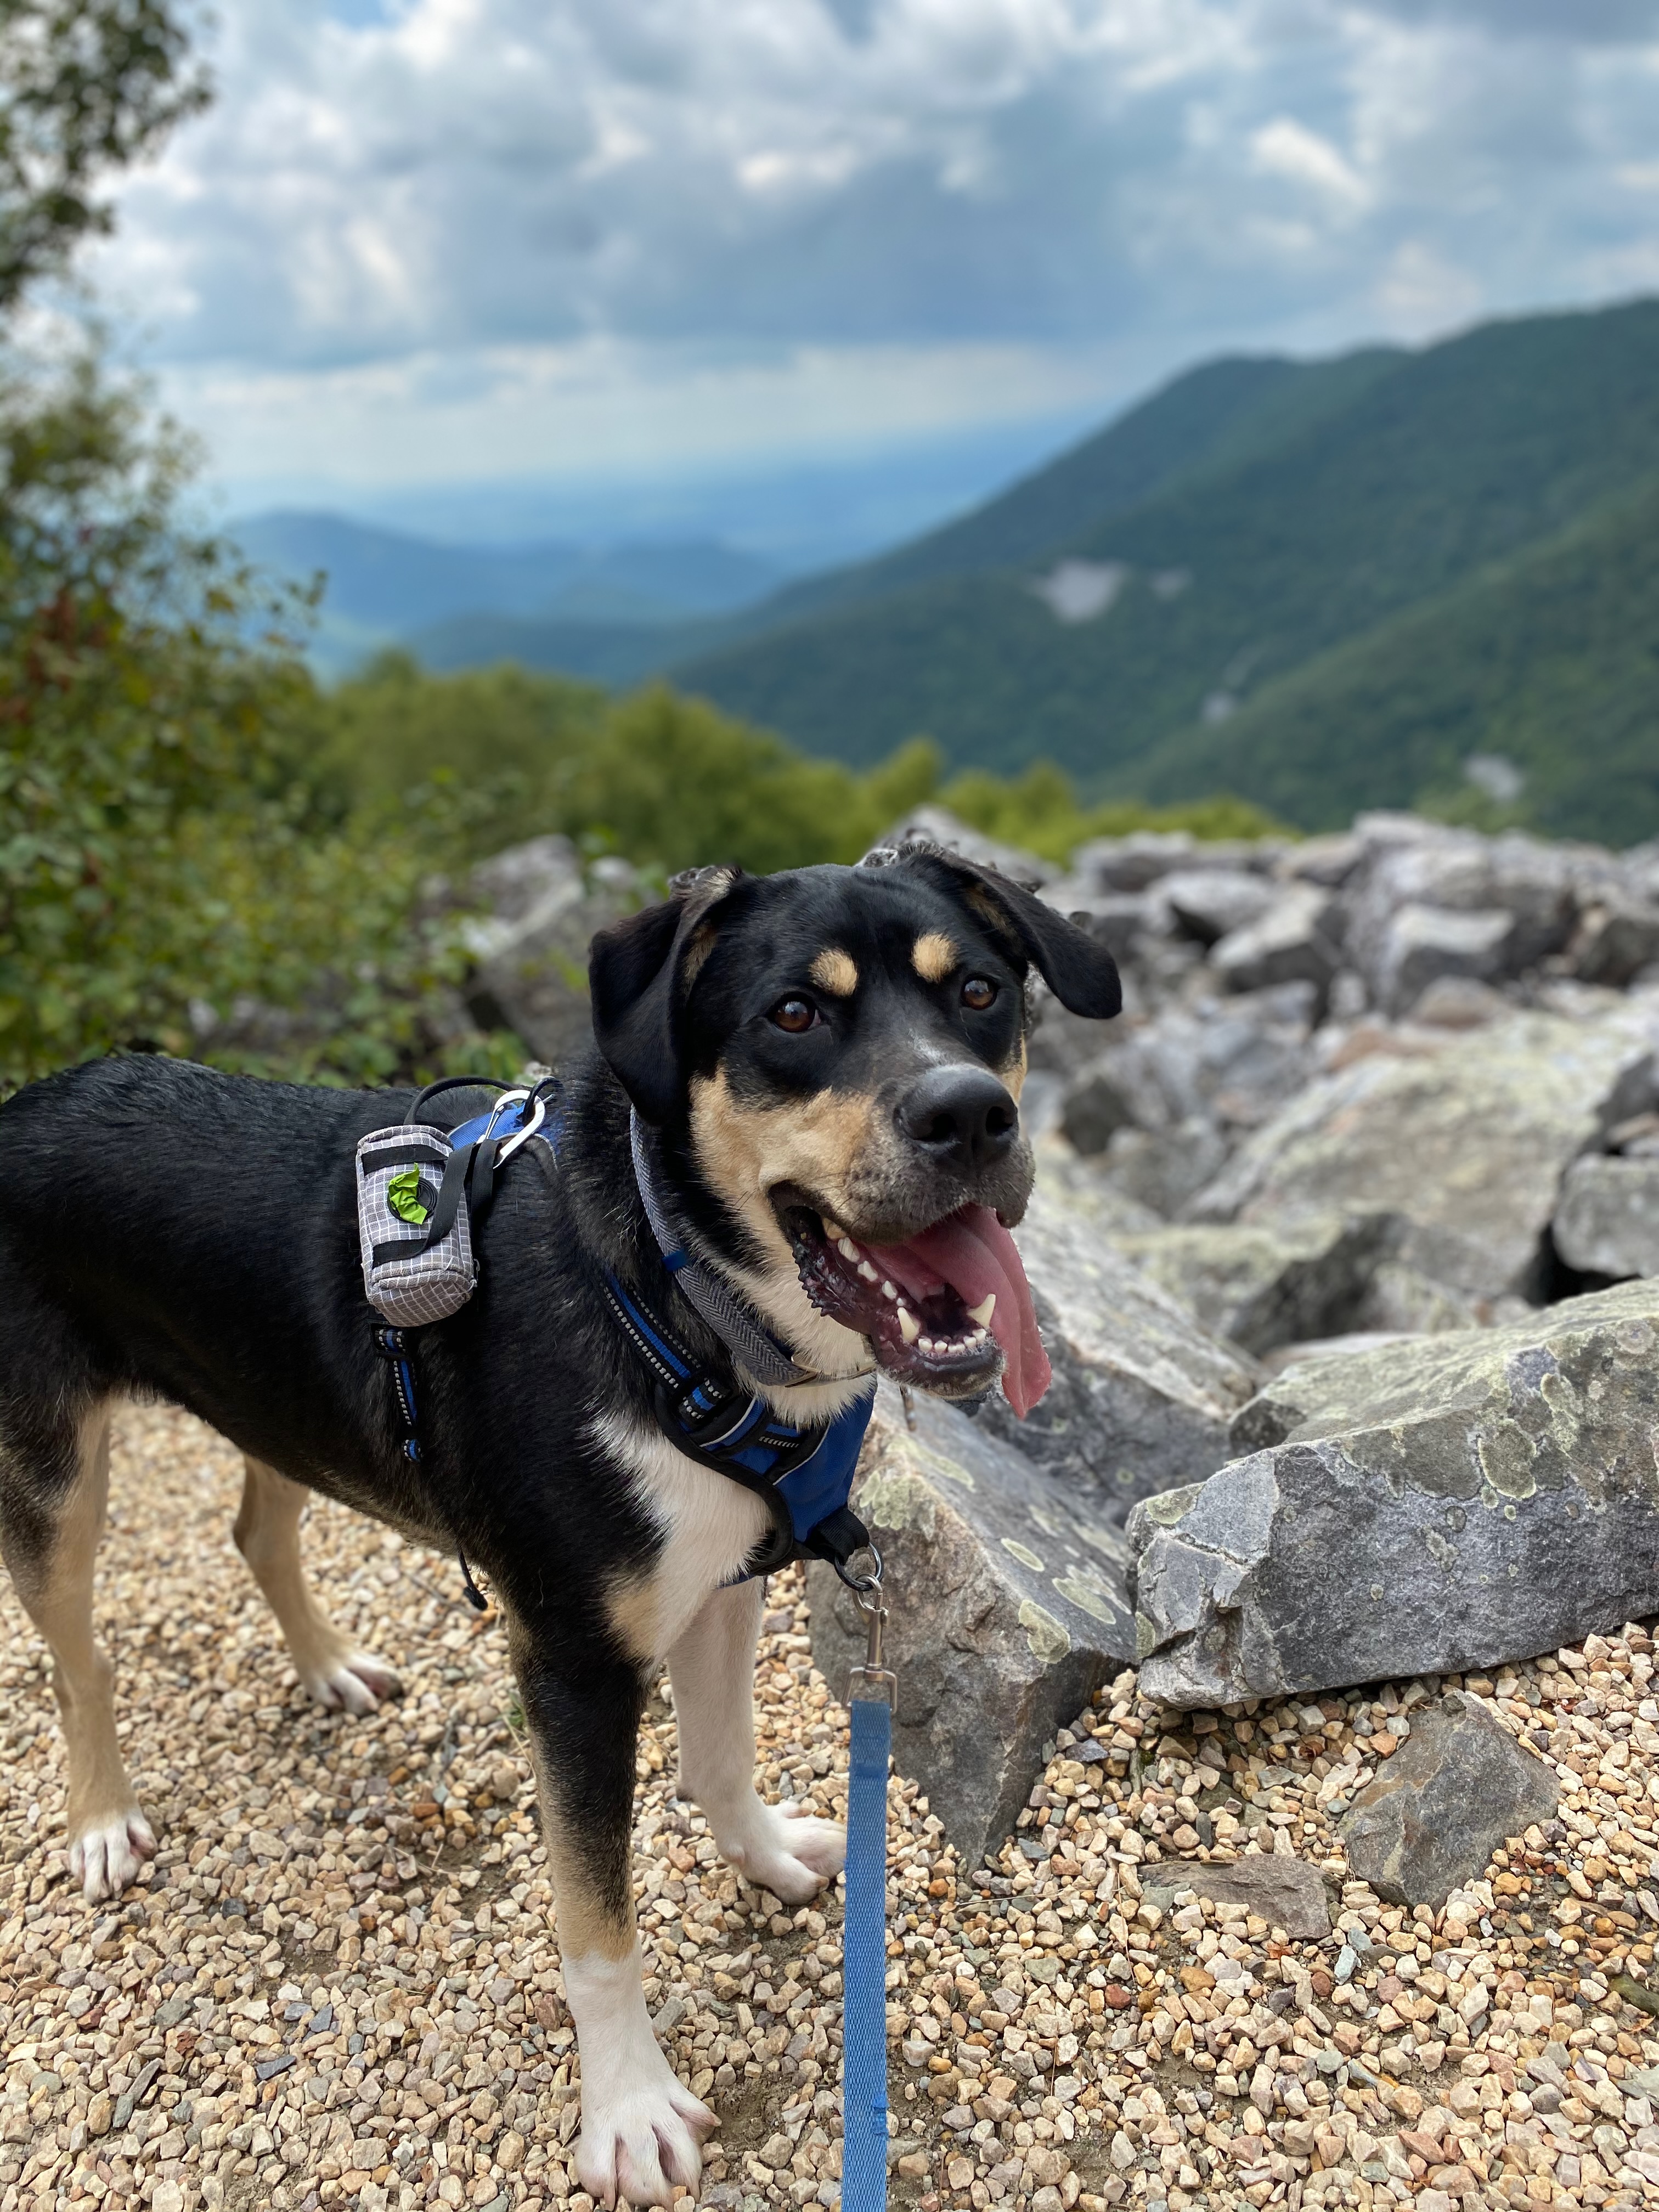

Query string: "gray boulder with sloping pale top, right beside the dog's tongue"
[[978, 1181, 1254, 1524]]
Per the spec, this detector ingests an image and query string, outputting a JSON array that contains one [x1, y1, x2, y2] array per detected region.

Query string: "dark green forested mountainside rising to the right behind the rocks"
[[654, 301, 1659, 836]]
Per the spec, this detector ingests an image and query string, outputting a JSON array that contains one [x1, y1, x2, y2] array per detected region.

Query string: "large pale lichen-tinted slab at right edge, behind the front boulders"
[[1188, 1000, 1659, 1299]]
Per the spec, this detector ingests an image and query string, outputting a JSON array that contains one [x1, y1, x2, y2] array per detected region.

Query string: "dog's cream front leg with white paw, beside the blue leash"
[[668, 1579, 847, 1905]]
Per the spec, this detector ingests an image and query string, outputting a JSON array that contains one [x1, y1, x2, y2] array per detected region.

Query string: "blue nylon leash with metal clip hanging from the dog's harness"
[[840, 1555, 898, 2212]]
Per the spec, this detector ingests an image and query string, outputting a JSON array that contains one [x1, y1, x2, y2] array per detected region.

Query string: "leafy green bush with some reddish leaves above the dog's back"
[[0, 356, 500, 1086]]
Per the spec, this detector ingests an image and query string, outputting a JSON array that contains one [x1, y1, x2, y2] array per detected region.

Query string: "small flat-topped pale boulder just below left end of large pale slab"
[[1113, 1215, 1402, 1356]]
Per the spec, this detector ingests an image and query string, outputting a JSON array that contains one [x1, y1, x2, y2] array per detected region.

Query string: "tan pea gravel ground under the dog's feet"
[[0, 1411, 1659, 2212]]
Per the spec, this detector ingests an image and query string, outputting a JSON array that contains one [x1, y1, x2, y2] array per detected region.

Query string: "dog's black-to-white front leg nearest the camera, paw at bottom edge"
[[513, 1630, 714, 2205]]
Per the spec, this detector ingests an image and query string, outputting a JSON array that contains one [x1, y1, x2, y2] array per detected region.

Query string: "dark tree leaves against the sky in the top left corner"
[[0, 0, 208, 314]]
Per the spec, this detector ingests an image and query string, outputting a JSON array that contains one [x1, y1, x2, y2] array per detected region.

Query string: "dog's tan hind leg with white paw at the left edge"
[[0, 1404, 155, 1905]]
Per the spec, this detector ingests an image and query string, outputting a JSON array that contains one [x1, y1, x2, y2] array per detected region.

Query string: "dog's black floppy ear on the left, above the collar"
[[589, 867, 743, 1126]]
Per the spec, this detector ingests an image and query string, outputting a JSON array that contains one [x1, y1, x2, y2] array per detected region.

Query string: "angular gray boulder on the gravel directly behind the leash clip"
[[808, 1383, 1135, 1865]]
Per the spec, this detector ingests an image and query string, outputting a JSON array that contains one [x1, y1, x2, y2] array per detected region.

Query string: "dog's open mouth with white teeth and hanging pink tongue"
[[778, 1203, 1048, 1418]]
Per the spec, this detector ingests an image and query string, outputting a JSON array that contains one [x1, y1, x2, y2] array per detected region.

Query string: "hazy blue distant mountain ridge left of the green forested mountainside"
[[228, 511, 781, 666]]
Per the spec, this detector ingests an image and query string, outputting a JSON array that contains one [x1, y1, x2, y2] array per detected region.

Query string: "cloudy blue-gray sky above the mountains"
[[93, 0, 1659, 531]]
